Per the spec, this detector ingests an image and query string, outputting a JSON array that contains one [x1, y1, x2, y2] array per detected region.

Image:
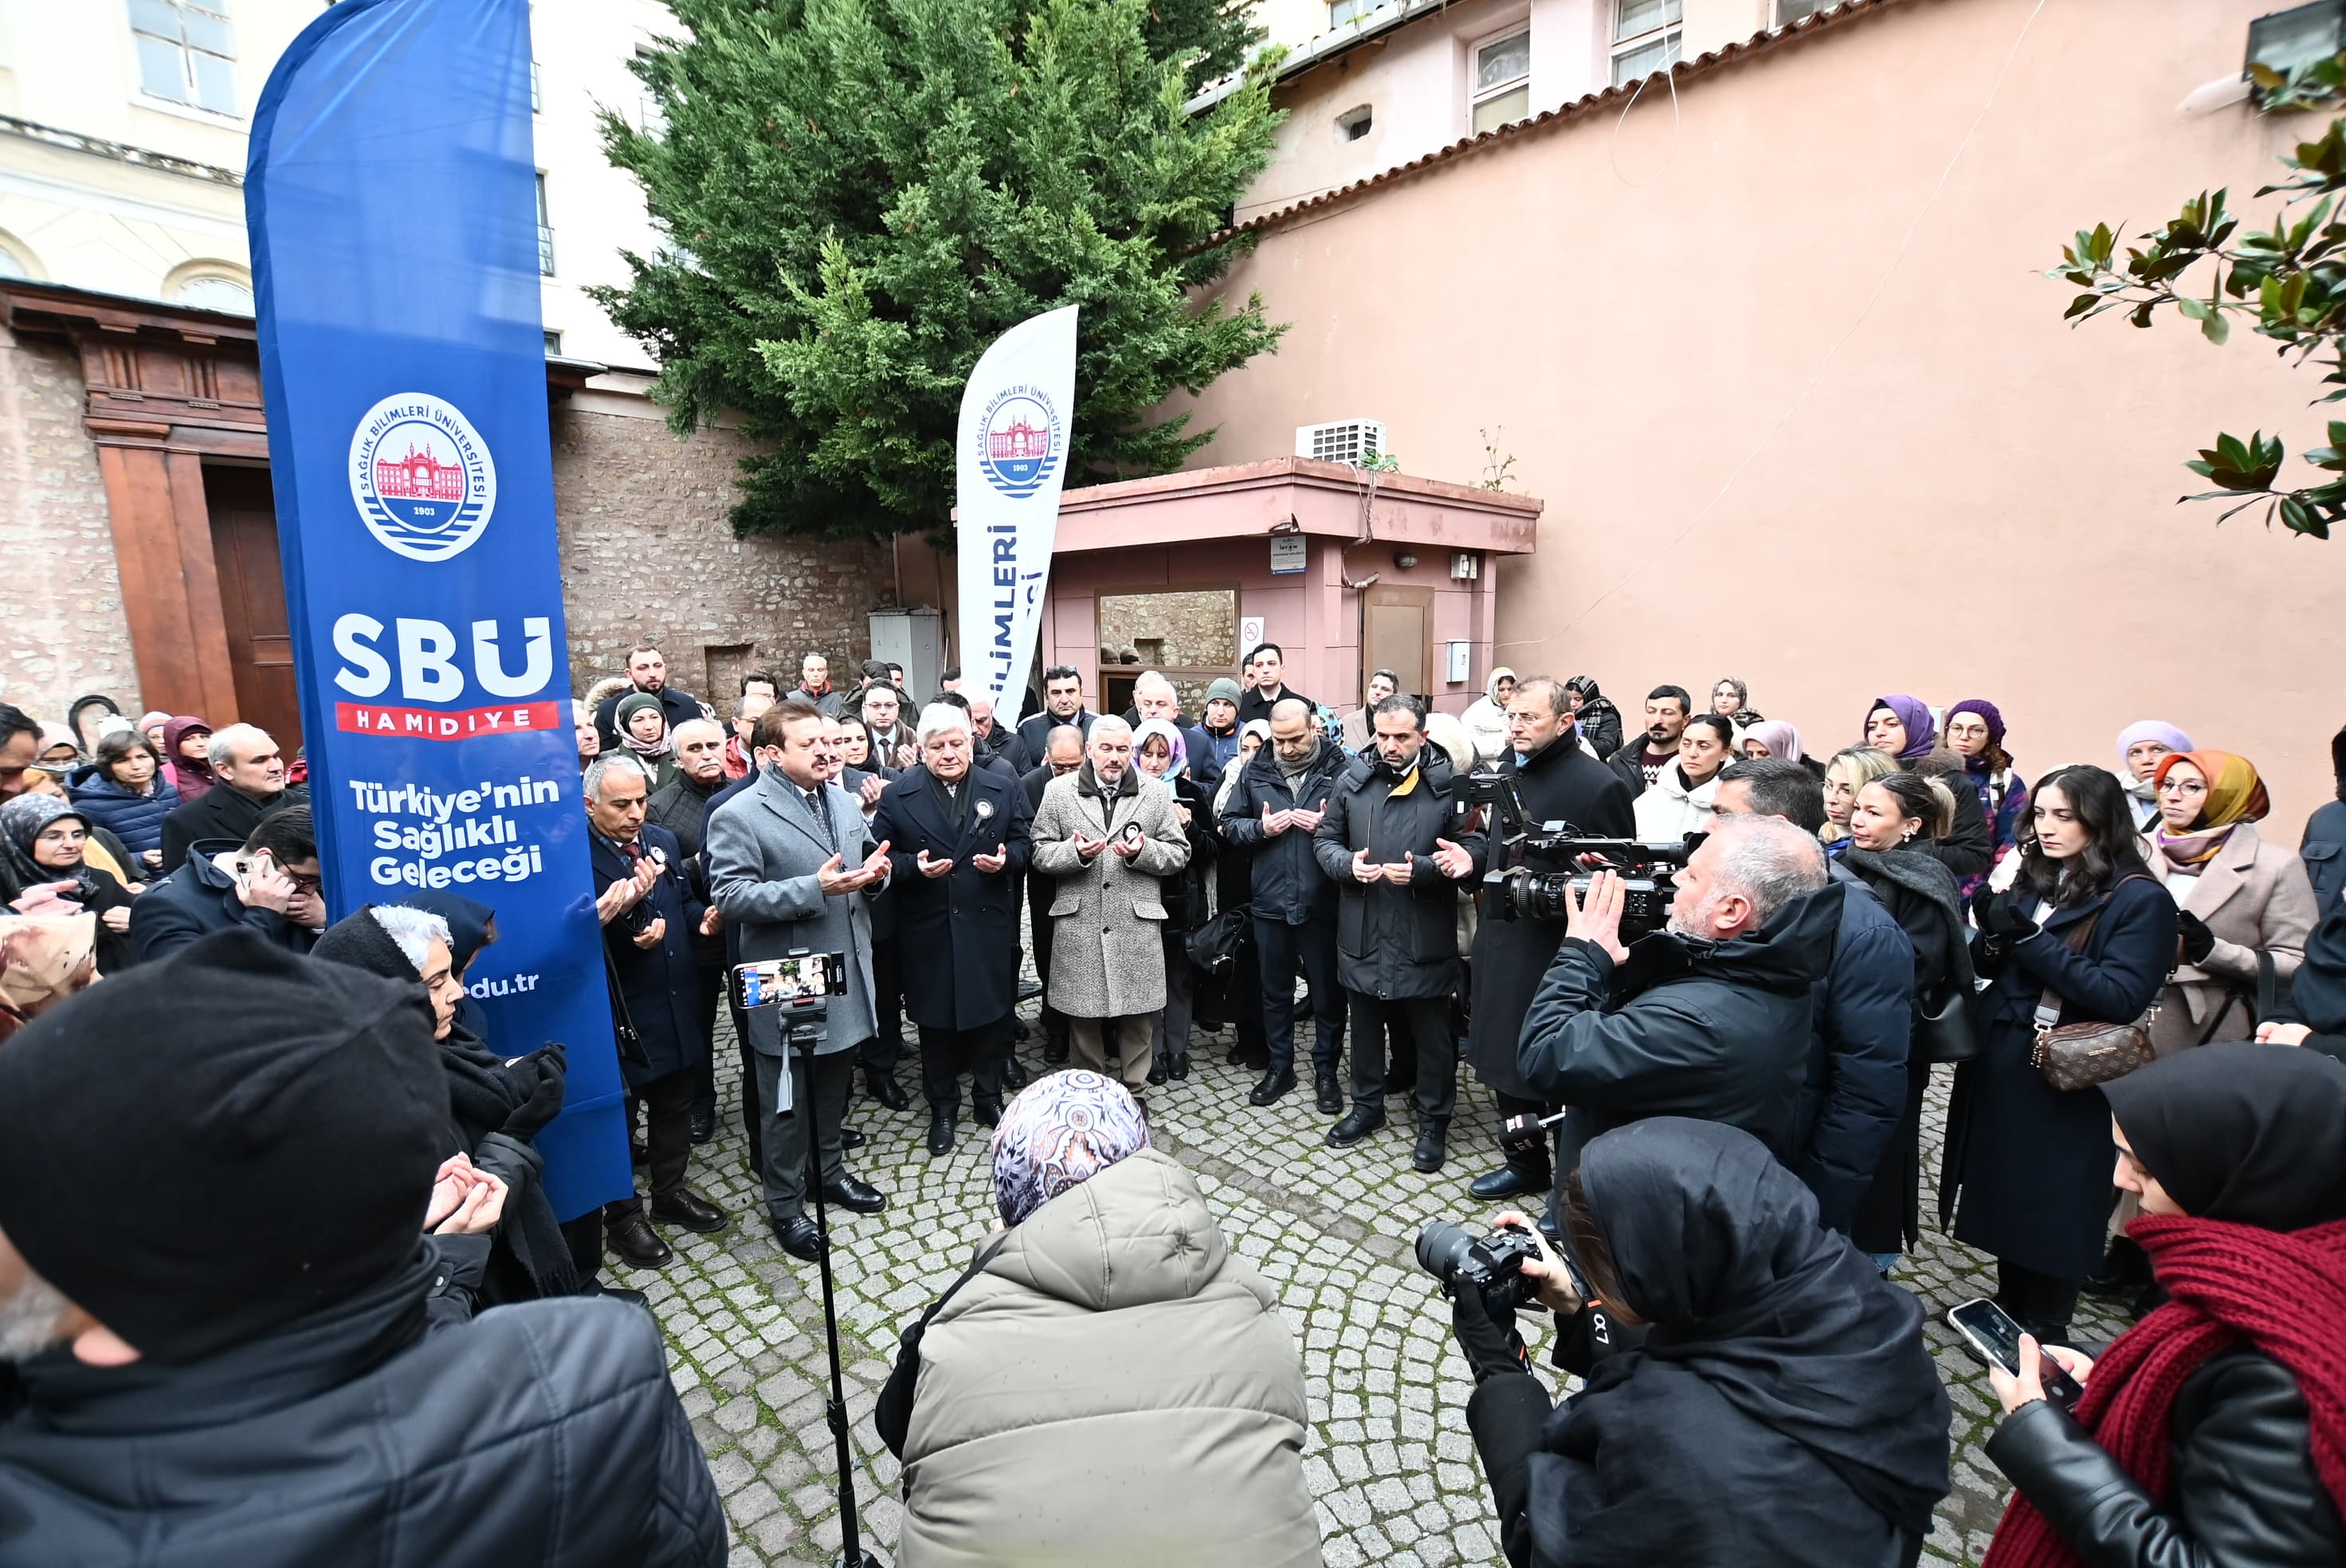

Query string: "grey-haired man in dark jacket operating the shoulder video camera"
[[1516, 817, 1842, 1164]]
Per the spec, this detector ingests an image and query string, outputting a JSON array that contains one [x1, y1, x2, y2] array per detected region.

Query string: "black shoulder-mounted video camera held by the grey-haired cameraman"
[[1452, 770, 1701, 941]]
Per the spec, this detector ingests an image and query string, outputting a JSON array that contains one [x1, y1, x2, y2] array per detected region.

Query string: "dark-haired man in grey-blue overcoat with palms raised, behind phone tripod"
[[708, 697, 889, 1263]]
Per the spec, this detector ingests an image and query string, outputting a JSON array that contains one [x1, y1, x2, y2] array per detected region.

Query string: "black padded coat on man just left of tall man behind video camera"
[[1304, 744, 1483, 1000]]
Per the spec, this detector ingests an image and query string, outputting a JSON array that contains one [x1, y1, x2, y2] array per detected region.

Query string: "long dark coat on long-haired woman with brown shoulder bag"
[[1940, 876, 2175, 1280]]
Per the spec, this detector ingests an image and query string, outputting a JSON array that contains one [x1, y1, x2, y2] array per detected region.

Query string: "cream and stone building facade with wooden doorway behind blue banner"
[[0, 0, 896, 732]]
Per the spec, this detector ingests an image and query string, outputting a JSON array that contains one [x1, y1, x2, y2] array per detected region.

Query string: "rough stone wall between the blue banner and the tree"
[[554, 404, 894, 707]]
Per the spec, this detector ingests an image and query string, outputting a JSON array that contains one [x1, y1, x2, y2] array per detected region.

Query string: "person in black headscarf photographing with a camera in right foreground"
[[1452, 1117, 1949, 1568]]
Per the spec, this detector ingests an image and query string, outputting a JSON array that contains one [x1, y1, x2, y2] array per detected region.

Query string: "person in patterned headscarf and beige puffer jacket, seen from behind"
[[882, 1070, 1320, 1568]]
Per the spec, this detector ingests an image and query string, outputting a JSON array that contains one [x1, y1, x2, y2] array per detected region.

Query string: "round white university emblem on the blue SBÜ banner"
[[350, 392, 497, 561]]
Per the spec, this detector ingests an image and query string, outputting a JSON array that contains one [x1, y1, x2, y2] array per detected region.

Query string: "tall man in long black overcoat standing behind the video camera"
[[1466, 676, 1638, 1201]]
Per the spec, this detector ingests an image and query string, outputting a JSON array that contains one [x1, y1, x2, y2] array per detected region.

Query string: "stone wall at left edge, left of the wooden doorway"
[[0, 328, 139, 720]]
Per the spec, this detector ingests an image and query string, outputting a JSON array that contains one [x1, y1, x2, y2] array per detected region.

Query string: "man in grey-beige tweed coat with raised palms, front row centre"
[[1027, 719, 1190, 1099]]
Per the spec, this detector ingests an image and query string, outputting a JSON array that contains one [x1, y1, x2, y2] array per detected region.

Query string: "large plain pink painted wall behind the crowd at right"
[[1173, 0, 2346, 843]]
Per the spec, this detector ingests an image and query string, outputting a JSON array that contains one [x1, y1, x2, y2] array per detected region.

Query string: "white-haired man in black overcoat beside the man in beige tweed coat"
[[873, 702, 1027, 1154]]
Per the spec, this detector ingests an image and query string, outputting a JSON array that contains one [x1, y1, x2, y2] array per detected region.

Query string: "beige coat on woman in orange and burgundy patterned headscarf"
[[2142, 821, 2313, 1056]]
